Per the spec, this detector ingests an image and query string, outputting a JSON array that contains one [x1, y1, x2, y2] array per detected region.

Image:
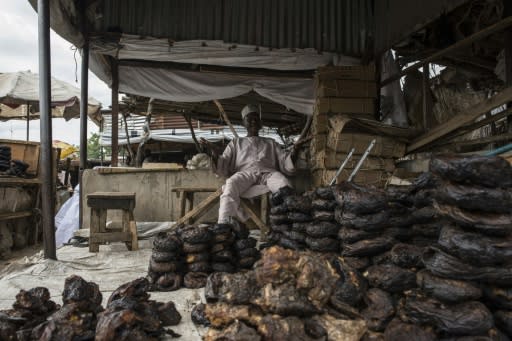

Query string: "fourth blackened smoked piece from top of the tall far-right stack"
[[438, 226, 512, 266]]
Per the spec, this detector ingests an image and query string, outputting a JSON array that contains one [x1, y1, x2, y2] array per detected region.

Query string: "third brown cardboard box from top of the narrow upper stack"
[[316, 97, 375, 115]]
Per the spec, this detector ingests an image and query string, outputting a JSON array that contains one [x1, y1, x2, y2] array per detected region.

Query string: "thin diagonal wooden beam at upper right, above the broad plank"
[[381, 16, 512, 87]]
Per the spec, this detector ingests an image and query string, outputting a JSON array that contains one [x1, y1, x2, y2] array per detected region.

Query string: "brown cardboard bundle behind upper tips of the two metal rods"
[[327, 130, 405, 158]]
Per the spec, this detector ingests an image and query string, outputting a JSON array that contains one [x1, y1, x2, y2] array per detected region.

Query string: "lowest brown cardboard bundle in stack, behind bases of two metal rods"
[[312, 169, 391, 188]]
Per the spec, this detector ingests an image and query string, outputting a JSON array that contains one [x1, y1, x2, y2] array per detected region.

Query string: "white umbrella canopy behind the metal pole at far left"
[[0, 71, 101, 120]]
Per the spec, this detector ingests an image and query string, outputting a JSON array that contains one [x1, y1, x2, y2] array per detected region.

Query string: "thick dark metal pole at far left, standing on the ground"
[[37, 0, 57, 259]]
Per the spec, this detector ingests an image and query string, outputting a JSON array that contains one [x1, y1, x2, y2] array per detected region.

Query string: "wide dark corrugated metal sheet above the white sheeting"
[[100, 0, 374, 56]]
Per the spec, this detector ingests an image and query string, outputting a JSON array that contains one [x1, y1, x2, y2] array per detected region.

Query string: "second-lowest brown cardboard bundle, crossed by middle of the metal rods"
[[312, 149, 395, 172]]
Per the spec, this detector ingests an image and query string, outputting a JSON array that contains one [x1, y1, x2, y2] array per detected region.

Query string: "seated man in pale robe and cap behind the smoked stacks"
[[200, 105, 296, 224]]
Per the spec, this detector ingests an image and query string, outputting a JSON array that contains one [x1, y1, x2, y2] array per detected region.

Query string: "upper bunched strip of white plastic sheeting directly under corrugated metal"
[[90, 34, 358, 70]]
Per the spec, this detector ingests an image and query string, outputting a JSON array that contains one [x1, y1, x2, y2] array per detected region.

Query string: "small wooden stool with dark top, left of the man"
[[87, 192, 139, 252]]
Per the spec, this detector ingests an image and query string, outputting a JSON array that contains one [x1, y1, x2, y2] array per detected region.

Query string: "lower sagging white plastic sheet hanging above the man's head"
[[119, 66, 315, 115]]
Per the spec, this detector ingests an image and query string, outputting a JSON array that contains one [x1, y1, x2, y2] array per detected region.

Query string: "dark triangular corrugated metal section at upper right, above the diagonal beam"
[[375, 0, 468, 55]]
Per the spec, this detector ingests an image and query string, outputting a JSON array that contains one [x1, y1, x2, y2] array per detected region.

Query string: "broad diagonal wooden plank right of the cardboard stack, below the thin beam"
[[407, 87, 512, 153]]
